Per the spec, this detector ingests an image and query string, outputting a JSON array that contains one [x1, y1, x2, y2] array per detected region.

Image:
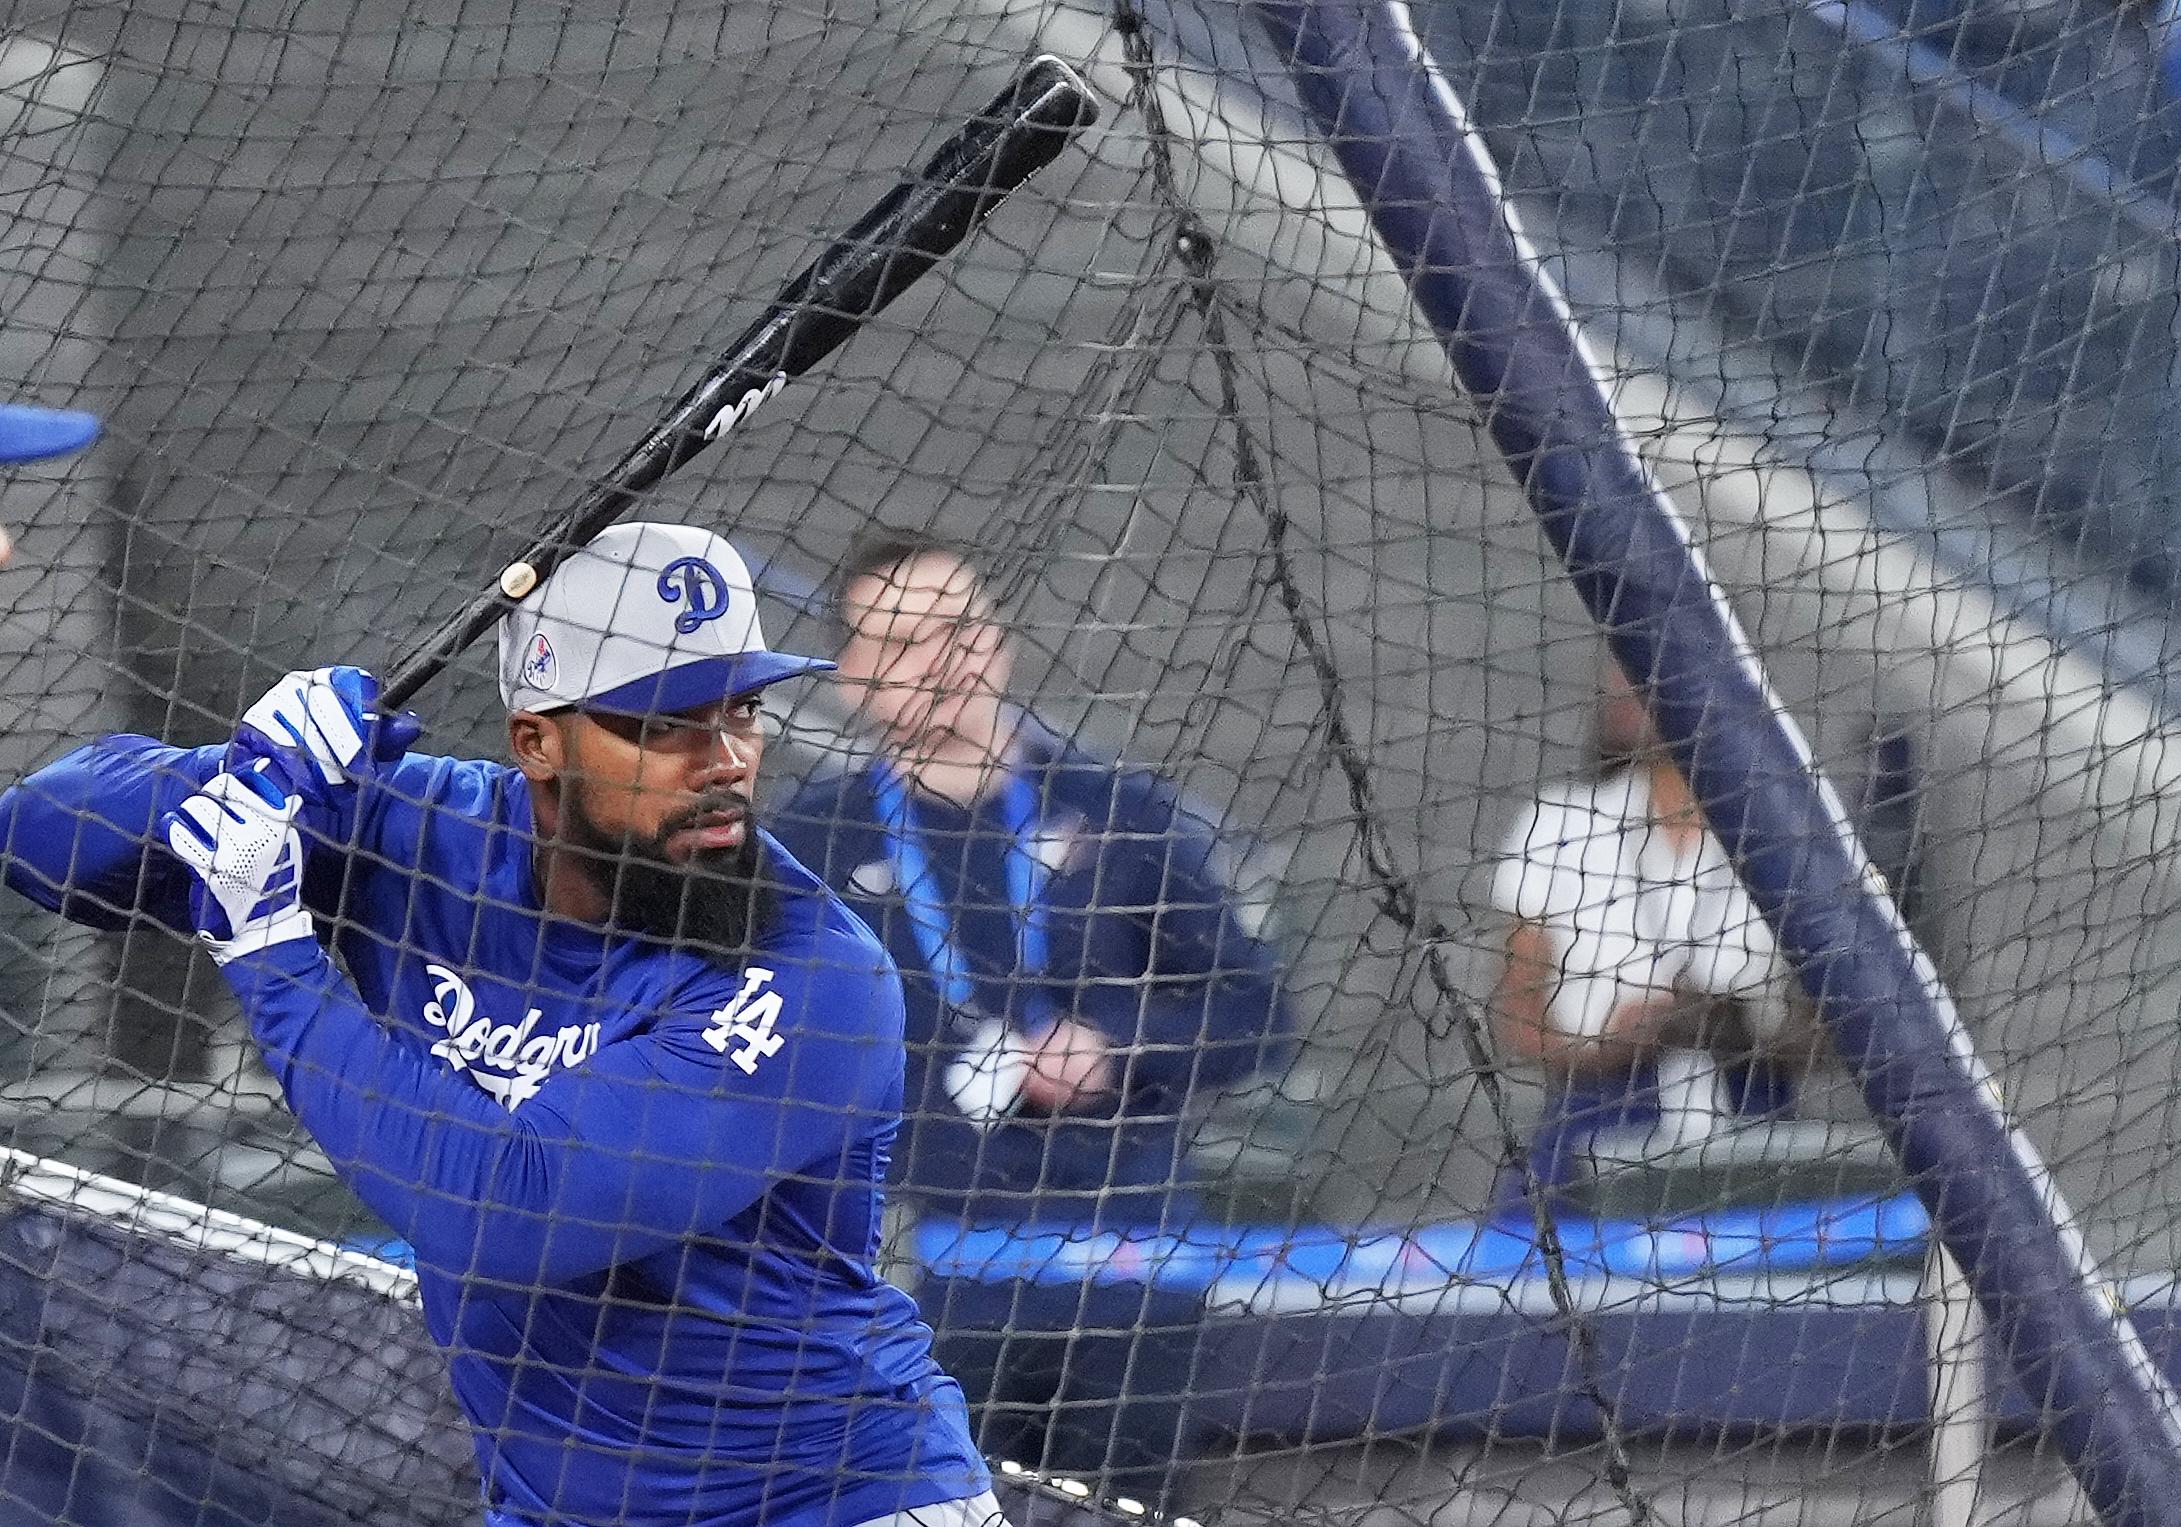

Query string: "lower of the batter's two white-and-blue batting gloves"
[[164, 768, 316, 964]]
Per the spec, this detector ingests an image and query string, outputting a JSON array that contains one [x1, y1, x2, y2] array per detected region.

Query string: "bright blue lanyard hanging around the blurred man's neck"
[[870, 764, 1058, 1025]]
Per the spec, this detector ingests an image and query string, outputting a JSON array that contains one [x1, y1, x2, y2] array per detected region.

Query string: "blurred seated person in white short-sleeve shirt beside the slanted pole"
[[1492, 661, 1815, 1187]]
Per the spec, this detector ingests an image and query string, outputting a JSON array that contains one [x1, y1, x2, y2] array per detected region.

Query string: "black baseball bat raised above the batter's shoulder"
[[379, 55, 1097, 711]]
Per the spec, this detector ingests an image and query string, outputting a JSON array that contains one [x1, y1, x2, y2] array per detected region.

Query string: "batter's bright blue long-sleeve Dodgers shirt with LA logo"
[[0, 737, 988, 1527]]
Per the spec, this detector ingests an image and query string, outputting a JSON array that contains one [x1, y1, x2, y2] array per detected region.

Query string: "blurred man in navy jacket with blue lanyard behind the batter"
[[779, 537, 1291, 1503]]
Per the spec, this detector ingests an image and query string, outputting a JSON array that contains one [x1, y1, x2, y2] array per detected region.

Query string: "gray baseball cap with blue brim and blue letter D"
[[499, 521, 833, 716]]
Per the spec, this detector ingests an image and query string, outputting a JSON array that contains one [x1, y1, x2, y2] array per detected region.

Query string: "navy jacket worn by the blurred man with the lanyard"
[[776, 718, 1291, 1224]]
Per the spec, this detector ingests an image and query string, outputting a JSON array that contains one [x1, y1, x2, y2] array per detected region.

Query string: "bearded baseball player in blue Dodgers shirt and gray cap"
[[0, 524, 999, 1527]]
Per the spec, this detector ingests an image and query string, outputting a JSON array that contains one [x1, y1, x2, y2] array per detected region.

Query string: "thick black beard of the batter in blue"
[[561, 787, 779, 951]]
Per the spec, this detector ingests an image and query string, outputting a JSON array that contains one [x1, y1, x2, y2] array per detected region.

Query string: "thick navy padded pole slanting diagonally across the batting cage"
[[1252, 0, 2181, 1527]]
